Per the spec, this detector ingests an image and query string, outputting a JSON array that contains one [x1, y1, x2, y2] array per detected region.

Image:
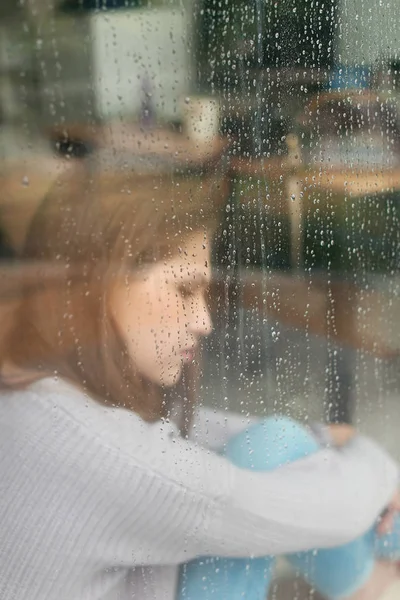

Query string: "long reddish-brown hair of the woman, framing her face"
[[0, 159, 224, 420]]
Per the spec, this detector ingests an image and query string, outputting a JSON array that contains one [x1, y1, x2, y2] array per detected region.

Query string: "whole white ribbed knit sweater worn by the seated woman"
[[0, 380, 397, 600]]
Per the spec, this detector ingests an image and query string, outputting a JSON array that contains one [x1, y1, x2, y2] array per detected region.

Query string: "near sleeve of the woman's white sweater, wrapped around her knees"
[[32, 396, 398, 566]]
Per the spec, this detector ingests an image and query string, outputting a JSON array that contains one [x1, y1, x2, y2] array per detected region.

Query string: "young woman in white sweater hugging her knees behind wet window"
[[0, 166, 400, 600]]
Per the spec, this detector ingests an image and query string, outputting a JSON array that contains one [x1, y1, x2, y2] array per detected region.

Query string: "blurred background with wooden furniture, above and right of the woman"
[[0, 0, 400, 600]]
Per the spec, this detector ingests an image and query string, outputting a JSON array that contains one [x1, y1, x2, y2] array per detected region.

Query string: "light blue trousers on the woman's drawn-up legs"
[[178, 417, 400, 600]]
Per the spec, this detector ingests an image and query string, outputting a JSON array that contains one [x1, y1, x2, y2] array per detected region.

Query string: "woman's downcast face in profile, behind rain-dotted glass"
[[111, 232, 212, 386]]
